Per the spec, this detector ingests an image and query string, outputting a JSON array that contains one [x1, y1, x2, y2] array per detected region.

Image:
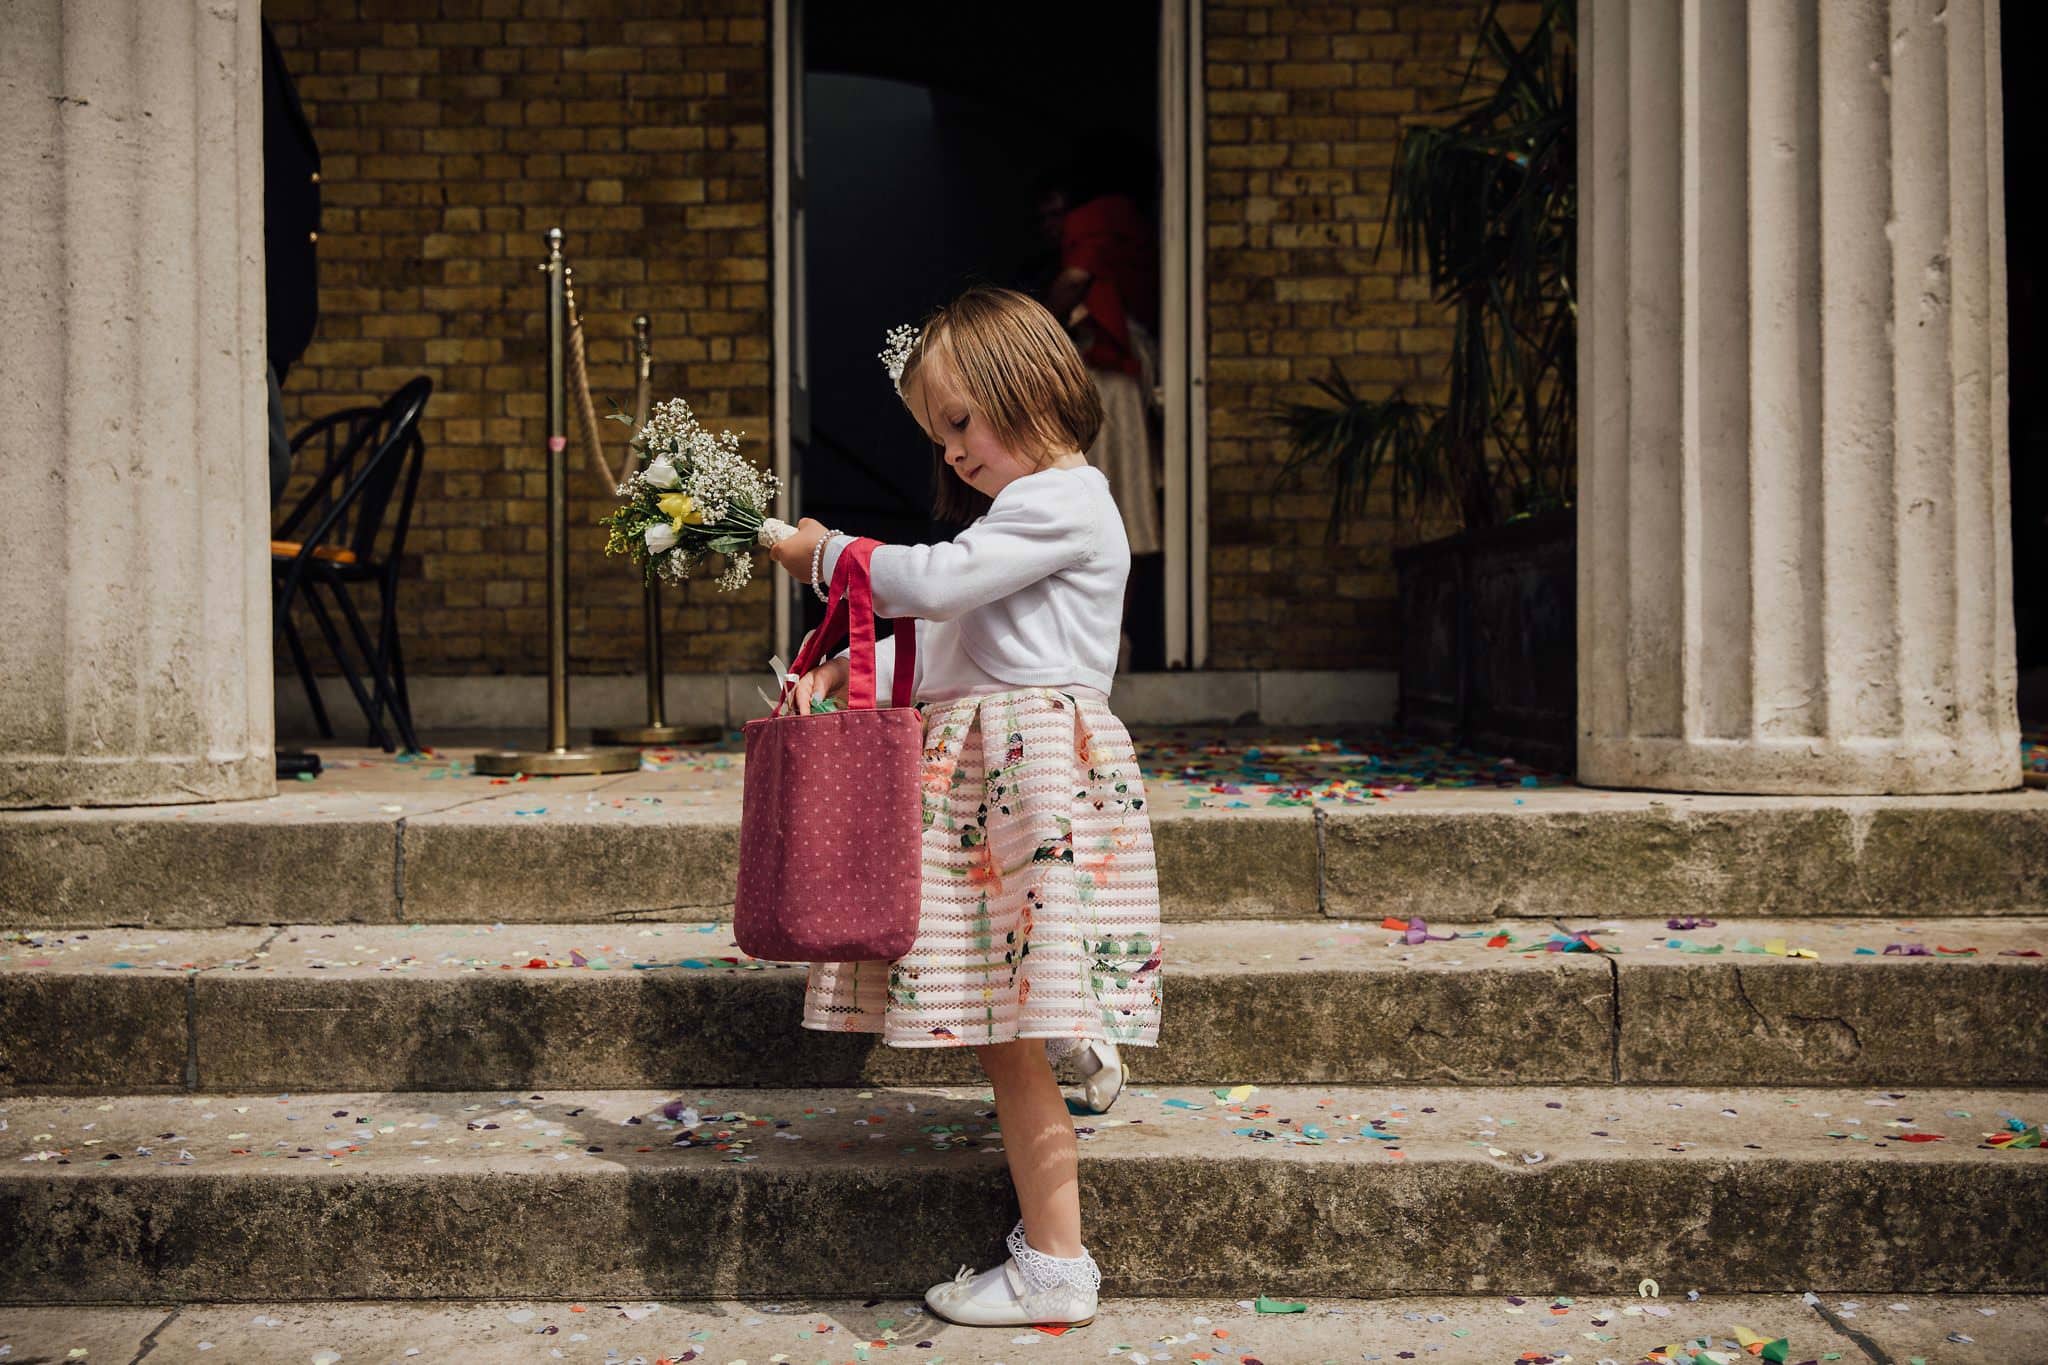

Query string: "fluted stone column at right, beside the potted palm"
[[1579, 0, 2019, 794]]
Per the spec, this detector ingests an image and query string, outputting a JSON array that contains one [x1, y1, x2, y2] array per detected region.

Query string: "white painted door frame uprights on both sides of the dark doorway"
[[768, 0, 1208, 667]]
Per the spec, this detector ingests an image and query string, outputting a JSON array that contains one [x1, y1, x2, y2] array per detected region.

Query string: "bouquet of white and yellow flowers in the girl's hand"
[[598, 399, 797, 591]]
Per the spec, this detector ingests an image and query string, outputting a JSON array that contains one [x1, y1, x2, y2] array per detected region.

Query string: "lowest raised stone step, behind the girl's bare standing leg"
[[0, 1078, 2048, 1304]]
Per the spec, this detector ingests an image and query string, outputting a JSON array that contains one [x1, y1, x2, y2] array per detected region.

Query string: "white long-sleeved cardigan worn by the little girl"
[[823, 465, 1130, 706]]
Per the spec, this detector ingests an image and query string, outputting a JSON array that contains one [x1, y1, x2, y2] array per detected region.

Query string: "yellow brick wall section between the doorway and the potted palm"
[[1202, 0, 1516, 667]]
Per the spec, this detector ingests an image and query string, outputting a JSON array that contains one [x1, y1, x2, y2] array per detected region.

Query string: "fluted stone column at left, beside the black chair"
[[0, 0, 274, 806]]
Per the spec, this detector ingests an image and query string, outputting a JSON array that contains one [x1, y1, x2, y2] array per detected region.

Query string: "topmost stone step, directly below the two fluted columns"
[[0, 755, 2048, 929]]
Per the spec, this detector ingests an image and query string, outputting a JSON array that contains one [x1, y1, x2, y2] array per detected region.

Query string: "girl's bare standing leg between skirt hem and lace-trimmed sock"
[[975, 1038, 1081, 1257]]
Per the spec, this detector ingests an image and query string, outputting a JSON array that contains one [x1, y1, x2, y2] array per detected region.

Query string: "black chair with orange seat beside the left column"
[[270, 375, 434, 753]]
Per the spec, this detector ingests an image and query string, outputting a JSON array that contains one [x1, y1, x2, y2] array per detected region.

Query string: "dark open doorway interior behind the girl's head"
[[795, 0, 1165, 667]]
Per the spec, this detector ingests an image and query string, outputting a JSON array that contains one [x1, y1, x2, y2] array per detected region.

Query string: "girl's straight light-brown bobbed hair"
[[897, 284, 1102, 522]]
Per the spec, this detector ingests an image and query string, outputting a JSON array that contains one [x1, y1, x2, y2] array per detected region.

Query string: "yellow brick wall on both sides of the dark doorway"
[[264, 0, 1481, 673]]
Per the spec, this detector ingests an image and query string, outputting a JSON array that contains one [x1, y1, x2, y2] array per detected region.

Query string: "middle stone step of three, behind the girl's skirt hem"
[[0, 919, 2048, 1093]]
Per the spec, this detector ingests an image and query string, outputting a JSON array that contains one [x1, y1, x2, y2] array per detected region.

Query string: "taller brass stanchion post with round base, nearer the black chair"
[[477, 227, 639, 778]]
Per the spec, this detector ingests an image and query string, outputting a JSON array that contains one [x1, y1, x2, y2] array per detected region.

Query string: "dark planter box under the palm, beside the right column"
[[1395, 512, 1579, 772]]
